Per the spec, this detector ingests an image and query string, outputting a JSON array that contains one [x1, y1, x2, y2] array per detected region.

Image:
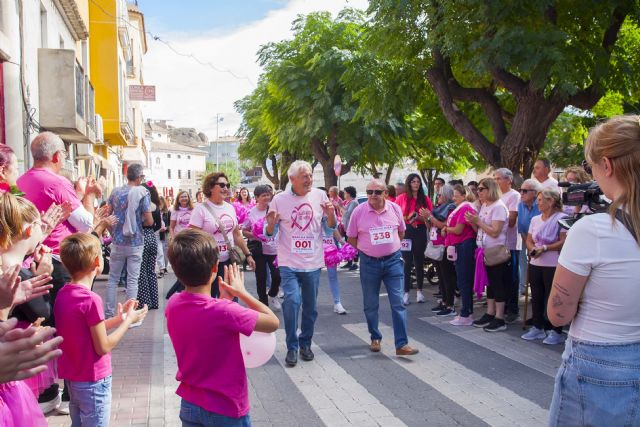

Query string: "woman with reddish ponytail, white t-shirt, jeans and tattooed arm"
[[547, 115, 640, 426]]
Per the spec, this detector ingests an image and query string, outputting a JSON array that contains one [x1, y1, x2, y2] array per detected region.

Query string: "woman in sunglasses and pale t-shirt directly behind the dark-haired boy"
[[189, 172, 256, 298]]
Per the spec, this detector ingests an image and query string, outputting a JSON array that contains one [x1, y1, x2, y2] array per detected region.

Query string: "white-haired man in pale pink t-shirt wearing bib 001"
[[265, 160, 337, 366]]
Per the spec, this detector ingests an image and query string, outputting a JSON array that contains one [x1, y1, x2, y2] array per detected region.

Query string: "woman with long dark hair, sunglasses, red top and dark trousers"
[[396, 173, 433, 305]]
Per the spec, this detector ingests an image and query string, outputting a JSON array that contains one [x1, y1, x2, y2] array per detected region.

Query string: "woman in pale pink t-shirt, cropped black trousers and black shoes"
[[465, 178, 511, 332]]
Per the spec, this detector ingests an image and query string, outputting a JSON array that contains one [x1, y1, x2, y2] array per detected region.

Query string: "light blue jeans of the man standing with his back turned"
[[104, 245, 144, 319]]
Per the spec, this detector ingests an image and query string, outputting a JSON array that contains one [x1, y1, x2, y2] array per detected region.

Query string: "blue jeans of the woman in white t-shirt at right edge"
[[549, 337, 640, 426]]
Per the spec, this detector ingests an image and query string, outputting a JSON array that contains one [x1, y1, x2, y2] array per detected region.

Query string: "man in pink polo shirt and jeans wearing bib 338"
[[347, 179, 418, 356]]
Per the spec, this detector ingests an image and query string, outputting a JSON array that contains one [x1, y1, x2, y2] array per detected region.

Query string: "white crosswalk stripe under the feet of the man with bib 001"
[[275, 329, 406, 427]]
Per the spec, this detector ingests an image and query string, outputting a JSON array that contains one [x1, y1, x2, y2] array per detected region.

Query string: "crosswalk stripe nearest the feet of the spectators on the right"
[[420, 316, 562, 378]]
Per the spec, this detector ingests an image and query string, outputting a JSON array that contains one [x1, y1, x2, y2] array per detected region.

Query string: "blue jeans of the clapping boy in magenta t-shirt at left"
[[65, 375, 111, 427]]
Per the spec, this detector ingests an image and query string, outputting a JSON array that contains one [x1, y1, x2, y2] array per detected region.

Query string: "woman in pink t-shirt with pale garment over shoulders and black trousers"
[[522, 189, 567, 345]]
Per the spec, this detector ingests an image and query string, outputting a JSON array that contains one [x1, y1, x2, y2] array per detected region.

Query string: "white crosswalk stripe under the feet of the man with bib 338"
[[342, 323, 548, 426]]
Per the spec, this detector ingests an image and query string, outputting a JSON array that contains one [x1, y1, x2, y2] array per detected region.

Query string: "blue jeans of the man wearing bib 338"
[[360, 251, 409, 348]]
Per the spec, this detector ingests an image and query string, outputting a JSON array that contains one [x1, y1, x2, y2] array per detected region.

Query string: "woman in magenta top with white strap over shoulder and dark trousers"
[[444, 184, 476, 326]]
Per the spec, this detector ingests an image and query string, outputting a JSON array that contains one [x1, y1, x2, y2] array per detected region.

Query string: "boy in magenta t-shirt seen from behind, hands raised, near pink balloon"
[[165, 228, 280, 426]]
